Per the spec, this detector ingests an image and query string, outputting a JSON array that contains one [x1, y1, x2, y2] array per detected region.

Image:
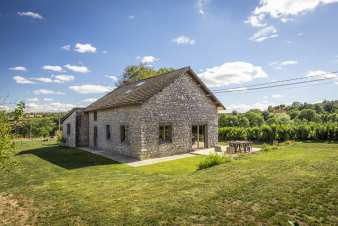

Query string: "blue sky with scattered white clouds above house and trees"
[[0, 0, 338, 111]]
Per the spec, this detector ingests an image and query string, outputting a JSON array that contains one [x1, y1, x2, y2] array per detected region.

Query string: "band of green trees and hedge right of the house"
[[219, 101, 338, 142]]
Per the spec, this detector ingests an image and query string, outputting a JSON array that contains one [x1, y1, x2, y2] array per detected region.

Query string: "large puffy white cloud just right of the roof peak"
[[198, 61, 268, 86]]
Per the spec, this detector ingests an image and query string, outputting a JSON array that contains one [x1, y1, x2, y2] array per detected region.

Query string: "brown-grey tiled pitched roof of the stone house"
[[85, 67, 224, 111]]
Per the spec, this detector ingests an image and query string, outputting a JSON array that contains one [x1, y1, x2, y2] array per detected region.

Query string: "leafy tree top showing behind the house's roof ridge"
[[117, 64, 175, 86]]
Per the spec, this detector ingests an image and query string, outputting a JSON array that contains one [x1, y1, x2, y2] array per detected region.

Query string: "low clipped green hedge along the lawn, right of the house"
[[218, 123, 338, 142]]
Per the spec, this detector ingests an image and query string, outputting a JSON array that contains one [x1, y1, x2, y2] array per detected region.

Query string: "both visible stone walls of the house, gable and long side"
[[84, 72, 218, 159]]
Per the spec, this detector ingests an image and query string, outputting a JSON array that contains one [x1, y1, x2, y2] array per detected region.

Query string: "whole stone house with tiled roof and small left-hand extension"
[[62, 67, 225, 159]]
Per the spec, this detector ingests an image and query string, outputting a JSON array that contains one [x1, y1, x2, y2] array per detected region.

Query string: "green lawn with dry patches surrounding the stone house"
[[0, 141, 338, 225]]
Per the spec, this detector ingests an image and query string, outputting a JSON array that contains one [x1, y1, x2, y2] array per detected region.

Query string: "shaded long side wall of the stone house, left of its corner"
[[89, 106, 141, 158]]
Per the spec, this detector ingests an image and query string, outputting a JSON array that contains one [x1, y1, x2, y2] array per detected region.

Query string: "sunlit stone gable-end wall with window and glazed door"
[[140, 75, 218, 159]]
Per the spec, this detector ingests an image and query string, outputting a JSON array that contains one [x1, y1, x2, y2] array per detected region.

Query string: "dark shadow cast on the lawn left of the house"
[[17, 145, 119, 170]]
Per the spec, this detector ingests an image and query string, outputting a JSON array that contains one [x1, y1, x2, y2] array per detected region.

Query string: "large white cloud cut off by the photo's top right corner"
[[247, 0, 338, 27]]
